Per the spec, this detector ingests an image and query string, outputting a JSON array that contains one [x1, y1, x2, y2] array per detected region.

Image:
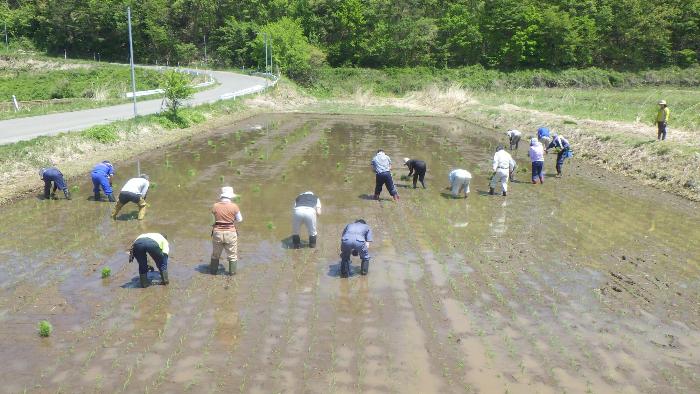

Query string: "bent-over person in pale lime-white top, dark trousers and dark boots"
[[129, 233, 170, 287]]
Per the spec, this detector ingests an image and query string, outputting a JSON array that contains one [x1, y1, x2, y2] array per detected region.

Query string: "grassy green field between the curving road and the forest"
[[0, 52, 208, 120]]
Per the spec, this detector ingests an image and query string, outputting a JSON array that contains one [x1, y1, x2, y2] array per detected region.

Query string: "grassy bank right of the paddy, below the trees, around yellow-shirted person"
[[306, 67, 700, 201]]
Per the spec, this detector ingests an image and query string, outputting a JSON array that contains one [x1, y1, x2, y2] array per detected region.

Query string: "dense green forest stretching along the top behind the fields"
[[0, 0, 700, 79]]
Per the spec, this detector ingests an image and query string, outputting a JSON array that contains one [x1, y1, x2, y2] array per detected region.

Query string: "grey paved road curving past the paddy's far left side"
[[0, 71, 267, 144]]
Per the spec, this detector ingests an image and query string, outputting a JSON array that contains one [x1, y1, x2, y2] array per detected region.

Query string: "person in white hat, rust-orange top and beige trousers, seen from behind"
[[209, 186, 243, 275]]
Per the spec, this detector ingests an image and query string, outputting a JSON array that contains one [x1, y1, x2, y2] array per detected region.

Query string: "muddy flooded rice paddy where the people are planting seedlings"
[[0, 114, 700, 393]]
